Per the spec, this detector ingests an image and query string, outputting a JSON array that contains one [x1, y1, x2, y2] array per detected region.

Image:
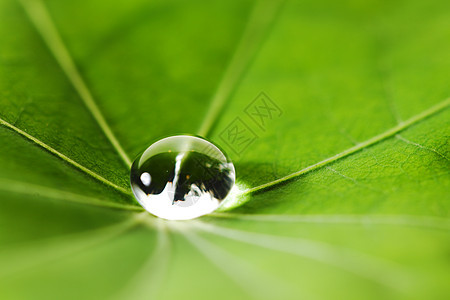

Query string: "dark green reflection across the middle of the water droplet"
[[131, 152, 233, 202]]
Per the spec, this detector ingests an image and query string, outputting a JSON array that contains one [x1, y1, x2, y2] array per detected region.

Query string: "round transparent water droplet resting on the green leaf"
[[130, 135, 235, 220]]
